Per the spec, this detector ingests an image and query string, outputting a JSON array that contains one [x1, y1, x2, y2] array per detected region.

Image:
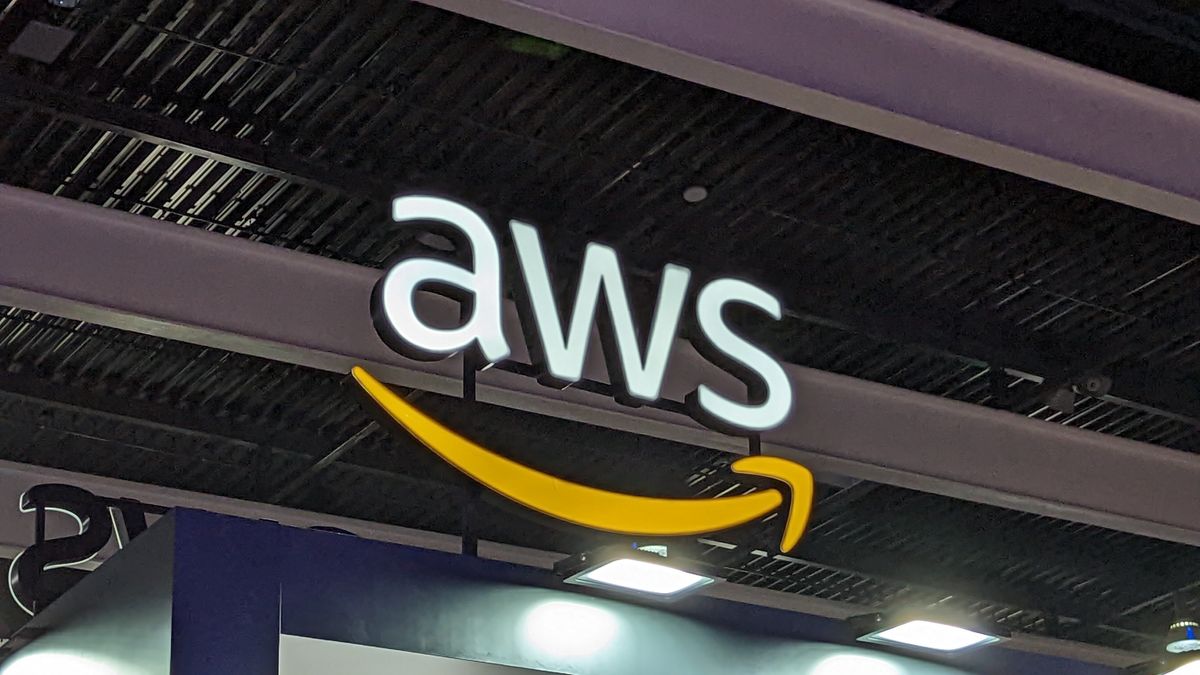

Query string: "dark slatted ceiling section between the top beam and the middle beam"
[[5, 2, 1200, 429]]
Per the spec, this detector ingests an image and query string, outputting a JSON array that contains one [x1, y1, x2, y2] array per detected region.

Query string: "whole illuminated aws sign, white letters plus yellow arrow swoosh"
[[364, 195, 814, 551]]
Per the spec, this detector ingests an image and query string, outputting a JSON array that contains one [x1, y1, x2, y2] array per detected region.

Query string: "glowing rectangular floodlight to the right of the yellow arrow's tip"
[[851, 614, 1008, 655]]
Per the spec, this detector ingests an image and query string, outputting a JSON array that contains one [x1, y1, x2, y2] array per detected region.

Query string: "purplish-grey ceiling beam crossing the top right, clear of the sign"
[[421, 0, 1200, 223]]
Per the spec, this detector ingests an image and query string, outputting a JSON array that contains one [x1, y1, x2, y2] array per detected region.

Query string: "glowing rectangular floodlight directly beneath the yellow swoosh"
[[554, 546, 719, 601]]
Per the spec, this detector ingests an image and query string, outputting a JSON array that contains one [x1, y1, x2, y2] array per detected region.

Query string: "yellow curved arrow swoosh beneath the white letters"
[[350, 366, 814, 551]]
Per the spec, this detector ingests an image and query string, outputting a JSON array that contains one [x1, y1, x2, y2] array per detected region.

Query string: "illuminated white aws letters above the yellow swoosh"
[[372, 195, 792, 434]]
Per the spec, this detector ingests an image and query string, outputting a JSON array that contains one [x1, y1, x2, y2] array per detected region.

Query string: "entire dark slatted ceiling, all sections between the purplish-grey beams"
[[0, 0, 1200, 653]]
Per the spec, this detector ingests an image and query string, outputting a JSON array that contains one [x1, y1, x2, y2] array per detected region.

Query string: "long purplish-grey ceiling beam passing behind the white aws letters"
[[7, 186, 1200, 545]]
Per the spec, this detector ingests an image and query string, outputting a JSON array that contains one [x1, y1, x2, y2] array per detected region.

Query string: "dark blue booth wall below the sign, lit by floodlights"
[[169, 509, 1115, 675]]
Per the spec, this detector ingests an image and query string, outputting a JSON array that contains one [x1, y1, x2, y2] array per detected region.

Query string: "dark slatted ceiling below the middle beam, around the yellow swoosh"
[[0, 305, 1194, 649]]
